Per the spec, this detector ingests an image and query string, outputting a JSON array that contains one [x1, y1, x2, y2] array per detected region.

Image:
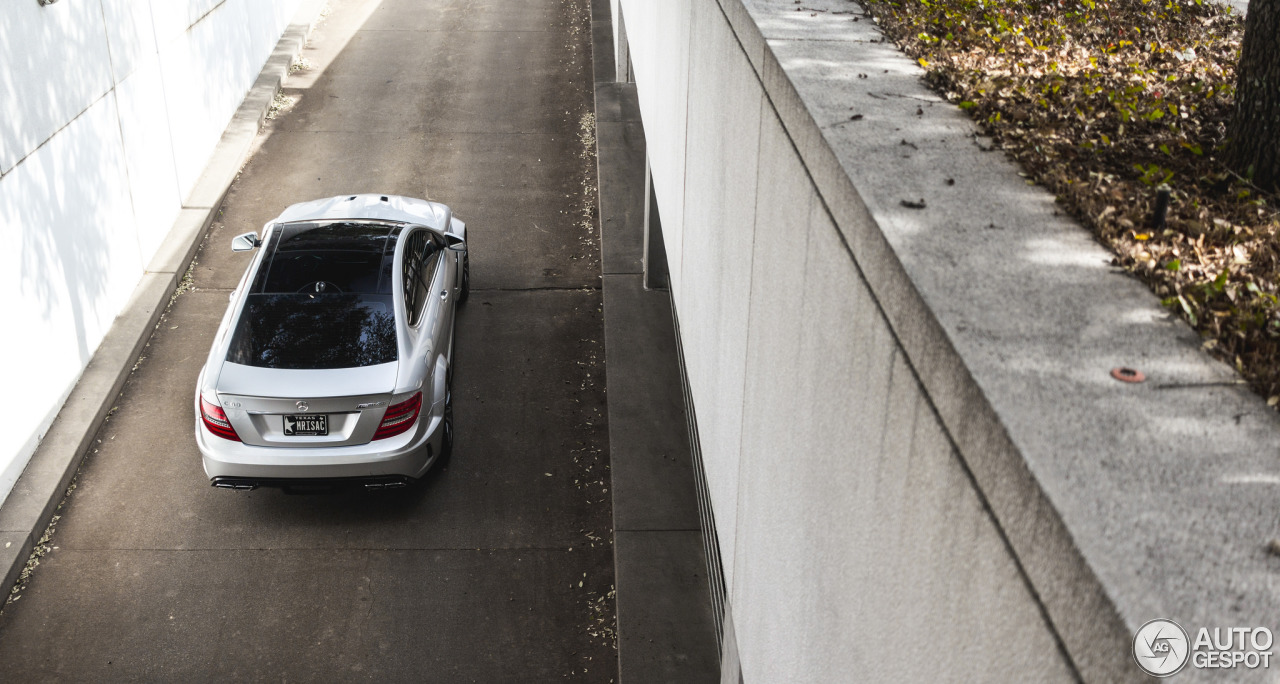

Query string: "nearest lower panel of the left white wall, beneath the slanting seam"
[[0, 95, 142, 494]]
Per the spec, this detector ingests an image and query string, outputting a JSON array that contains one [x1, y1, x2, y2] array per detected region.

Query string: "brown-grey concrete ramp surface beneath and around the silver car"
[[0, 0, 617, 681]]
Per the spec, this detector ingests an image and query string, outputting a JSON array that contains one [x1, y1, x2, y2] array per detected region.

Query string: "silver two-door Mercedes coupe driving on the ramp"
[[195, 195, 470, 489]]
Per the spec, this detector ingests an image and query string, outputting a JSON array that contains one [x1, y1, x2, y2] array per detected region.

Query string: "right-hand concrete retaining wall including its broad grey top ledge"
[[616, 0, 1280, 683]]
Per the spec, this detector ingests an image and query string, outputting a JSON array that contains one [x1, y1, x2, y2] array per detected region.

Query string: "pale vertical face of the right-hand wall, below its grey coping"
[[622, 0, 1070, 681]]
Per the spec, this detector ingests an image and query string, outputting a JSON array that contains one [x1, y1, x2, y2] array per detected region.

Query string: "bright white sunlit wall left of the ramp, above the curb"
[[0, 0, 298, 501]]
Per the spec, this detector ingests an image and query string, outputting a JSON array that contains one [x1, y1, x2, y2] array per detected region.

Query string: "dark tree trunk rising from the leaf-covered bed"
[[1228, 0, 1280, 190]]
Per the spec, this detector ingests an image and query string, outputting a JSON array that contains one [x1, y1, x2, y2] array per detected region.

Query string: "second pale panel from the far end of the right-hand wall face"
[[680, 3, 768, 594]]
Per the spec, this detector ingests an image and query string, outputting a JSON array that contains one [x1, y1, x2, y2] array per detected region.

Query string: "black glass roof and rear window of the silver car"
[[227, 223, 399, 369]]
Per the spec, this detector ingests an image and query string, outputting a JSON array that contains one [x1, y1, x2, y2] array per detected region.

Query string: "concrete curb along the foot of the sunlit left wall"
[[0, 0, 325, 599]]
